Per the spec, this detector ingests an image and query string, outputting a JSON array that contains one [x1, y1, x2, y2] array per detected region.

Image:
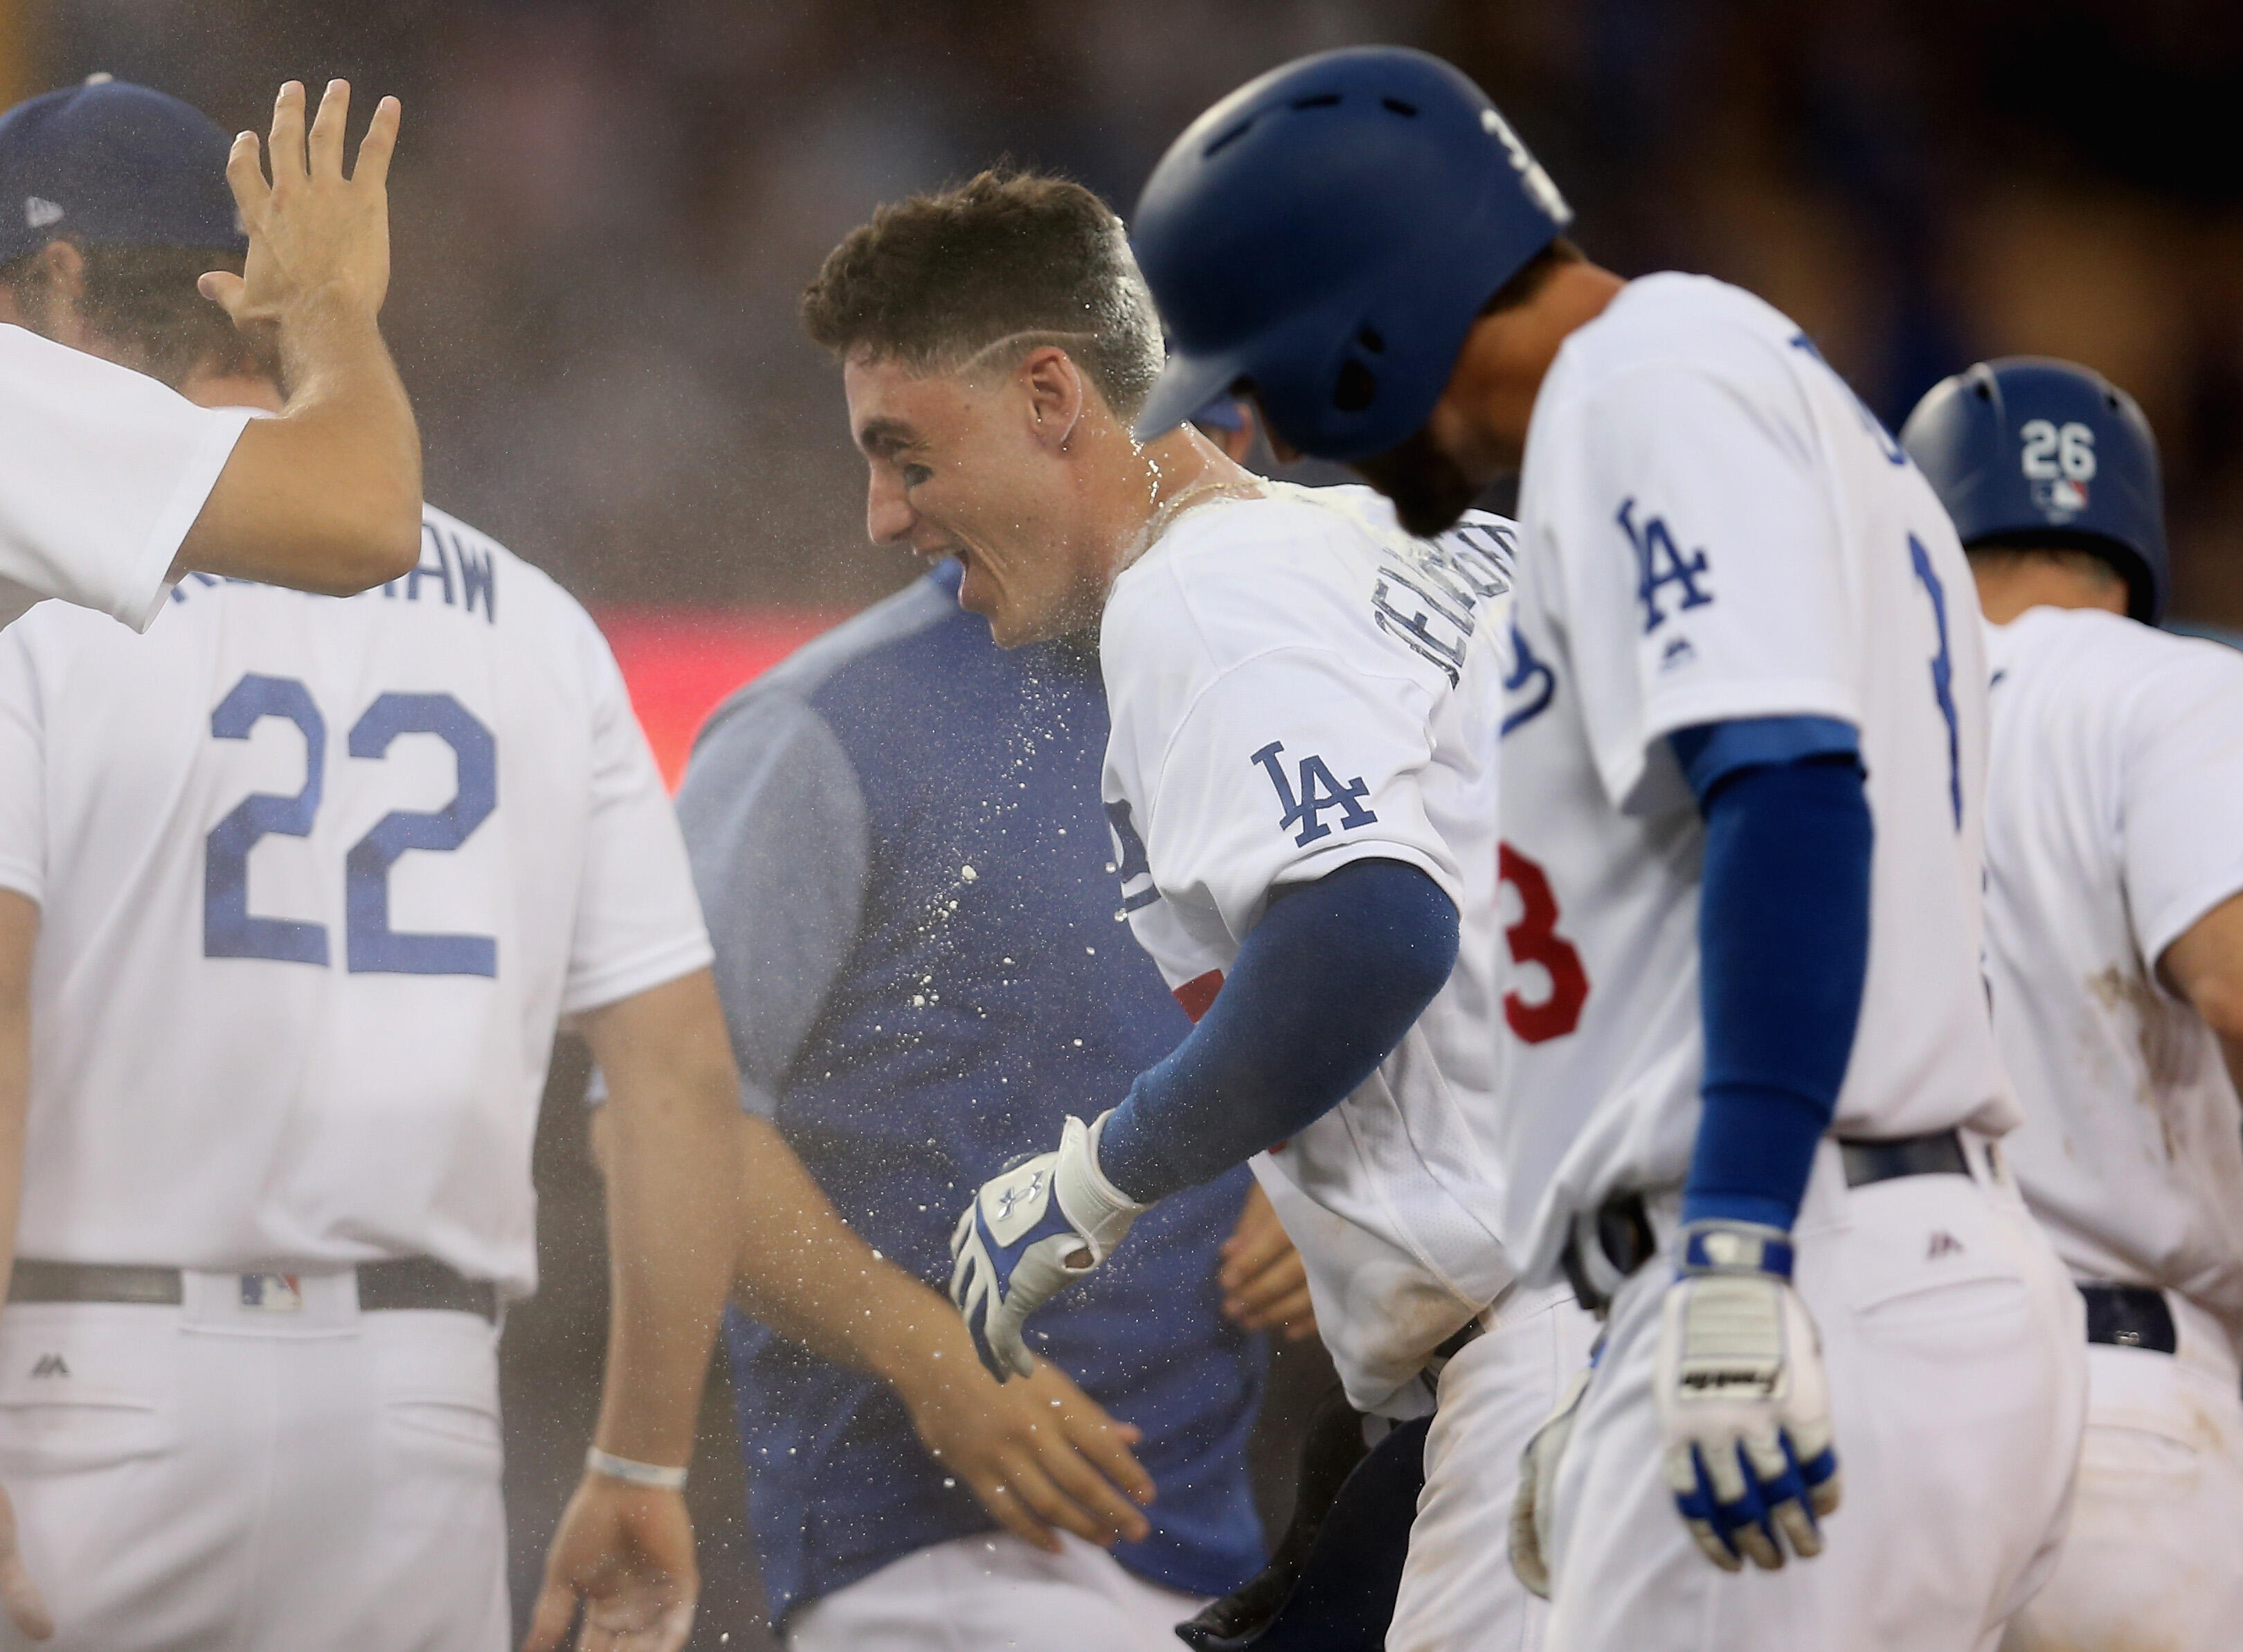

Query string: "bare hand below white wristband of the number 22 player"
[[523, 1475, 700, 1652]]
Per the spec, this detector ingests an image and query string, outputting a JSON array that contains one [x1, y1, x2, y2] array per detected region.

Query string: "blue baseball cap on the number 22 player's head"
[[0, 74, 249, 262]]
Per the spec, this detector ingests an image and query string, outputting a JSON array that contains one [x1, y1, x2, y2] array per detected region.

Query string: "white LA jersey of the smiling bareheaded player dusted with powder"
[[1099, 483, 1512, 1410]]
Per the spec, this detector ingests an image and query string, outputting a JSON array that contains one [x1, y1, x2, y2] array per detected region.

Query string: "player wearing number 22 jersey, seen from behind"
[[0, 92, 736, 1652]]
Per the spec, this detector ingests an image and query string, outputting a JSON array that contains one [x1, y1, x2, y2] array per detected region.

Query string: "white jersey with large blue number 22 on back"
[[0, 496, 709, 1293]]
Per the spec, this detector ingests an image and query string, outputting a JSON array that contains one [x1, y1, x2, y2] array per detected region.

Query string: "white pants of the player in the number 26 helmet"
[[2001, 1291, 2243, 1652]]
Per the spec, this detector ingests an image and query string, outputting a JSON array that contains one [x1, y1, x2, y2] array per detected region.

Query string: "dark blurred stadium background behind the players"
[[0, 0, 2243, 1648]]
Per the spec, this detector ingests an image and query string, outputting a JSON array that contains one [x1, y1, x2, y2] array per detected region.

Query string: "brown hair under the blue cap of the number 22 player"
[[0, 244, 278, 390]]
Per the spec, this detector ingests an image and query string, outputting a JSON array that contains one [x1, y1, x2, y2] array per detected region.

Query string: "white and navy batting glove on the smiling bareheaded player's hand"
[[951, 1113, 1144, 1383]]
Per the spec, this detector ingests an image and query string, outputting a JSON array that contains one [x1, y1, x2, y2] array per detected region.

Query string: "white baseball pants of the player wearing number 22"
[[0, 1273, 512, 1652]]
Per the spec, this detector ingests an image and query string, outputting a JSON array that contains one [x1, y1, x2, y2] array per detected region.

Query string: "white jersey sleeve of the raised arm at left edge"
[[0, 325, 251, 631]]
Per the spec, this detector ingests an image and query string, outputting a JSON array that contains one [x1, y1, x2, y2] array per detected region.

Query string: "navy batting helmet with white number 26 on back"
[[1900, 354, 2169, 626]]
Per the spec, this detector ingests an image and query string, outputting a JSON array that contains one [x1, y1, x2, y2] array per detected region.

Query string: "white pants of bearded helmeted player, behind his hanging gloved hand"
[[1543, 1135, 2086, 1652]]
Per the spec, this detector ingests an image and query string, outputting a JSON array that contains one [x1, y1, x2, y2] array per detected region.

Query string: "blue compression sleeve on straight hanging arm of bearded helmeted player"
[[1671, 718, 1873, 1228]]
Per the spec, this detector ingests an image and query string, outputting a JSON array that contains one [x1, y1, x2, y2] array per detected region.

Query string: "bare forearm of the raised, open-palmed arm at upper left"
[[172, 300, 422, 595]]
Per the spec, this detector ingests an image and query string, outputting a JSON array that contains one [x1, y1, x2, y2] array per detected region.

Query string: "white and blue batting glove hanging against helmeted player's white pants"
[[1653, 1221, 1837, 1571]]
